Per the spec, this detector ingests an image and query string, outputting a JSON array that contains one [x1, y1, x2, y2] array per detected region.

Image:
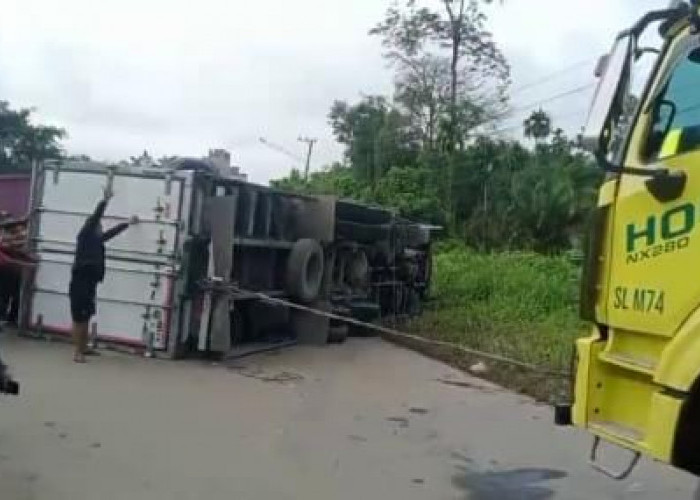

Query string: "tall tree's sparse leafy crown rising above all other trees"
[[370, 0, 510, 151]]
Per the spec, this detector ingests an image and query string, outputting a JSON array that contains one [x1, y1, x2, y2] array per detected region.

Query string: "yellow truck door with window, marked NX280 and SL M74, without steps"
[[608, 42, 700, 344]]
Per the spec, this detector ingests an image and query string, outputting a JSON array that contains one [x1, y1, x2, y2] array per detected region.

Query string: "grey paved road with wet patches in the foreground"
[[0, 337, 695, 500]]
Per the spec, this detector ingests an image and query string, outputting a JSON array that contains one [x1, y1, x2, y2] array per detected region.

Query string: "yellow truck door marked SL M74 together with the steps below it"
[[588, 38, 700, 459]]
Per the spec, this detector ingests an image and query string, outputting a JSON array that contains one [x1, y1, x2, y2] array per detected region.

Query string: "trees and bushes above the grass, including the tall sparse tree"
[[273, 0, 602, 253]]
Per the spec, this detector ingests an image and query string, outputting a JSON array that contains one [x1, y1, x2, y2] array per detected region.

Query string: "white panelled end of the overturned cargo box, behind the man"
[[25, 163, 194, 352]]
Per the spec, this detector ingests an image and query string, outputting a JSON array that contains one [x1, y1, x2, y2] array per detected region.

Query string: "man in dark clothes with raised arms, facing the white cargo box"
[[68, 188, 139, 363]]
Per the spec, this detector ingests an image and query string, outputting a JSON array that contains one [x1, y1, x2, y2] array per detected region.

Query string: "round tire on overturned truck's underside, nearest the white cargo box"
[[285, 239, 323, 303]]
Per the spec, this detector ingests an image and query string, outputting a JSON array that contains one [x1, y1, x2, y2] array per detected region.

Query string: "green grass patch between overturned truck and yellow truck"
[[408, 248, 585, 371]]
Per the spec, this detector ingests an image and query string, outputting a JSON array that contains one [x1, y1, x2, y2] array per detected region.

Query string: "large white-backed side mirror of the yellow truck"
[[582, 35, 634, 154]]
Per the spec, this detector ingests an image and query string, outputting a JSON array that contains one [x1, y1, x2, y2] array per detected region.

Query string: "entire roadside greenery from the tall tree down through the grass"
[[273, 0, 602, 376]]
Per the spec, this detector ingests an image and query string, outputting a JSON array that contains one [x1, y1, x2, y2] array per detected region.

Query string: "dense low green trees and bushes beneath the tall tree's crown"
[[273, 133, 601, 253]]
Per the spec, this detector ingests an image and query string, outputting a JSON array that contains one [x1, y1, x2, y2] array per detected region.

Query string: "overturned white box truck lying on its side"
[[22, 159, 431, 357]]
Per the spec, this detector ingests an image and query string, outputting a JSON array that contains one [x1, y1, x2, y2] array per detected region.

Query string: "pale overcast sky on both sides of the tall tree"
[[0, 0, 668, 183]]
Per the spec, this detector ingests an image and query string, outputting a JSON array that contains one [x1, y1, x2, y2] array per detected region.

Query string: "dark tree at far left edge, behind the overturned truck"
[[0, 101, 66, 171]]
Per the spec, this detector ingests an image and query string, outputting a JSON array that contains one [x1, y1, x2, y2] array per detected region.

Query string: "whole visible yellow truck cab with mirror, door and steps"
[[558, 0, 700, 478]]
